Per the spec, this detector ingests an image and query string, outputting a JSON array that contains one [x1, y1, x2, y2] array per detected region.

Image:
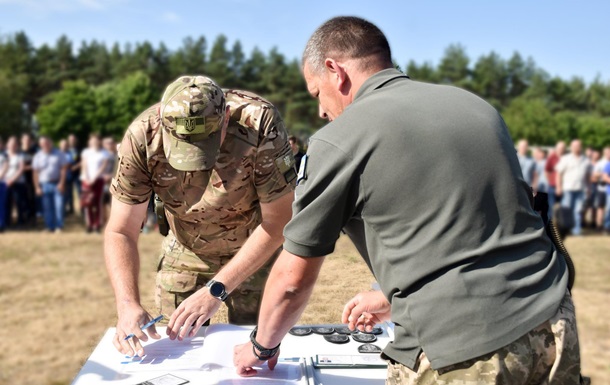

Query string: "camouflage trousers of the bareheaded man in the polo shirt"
[[386, 293, 587, 385]]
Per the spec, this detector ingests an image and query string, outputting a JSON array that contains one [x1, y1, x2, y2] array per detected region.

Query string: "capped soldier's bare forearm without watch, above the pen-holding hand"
[[104, 231, 140, 310]]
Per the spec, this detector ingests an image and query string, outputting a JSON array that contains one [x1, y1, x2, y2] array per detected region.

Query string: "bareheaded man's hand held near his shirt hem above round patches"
[[341, 291, 391, 332]]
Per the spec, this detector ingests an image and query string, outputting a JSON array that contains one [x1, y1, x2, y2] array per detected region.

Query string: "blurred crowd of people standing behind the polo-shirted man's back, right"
[[517, 139, 610, 236]]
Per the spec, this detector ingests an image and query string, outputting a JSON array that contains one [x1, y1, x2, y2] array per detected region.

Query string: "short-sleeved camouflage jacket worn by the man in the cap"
[[110, 90, 296, 257]]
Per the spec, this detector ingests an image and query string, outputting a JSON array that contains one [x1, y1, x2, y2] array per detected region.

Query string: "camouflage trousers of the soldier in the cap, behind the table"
[[155, 232, 279, 325]]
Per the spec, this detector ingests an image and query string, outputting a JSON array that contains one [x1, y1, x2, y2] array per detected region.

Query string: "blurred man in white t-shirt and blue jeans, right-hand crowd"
[[555, 139, 591, 235]]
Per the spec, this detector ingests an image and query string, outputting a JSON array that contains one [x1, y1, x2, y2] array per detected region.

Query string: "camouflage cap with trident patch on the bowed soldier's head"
[[160, 76, 225, 171]]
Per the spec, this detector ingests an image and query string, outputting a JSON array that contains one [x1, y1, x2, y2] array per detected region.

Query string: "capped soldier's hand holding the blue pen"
[[112, 305, 161, 357]]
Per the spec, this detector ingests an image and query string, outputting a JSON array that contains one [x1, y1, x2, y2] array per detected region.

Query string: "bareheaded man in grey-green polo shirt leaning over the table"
[[234, 17, 580, 385]]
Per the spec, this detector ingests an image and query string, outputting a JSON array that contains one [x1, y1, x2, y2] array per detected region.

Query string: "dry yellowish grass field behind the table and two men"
[[0, 218, 610, 385]]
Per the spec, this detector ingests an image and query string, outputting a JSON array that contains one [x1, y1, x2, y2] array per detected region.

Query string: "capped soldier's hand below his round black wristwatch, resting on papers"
[[166, 287, 221, 341]]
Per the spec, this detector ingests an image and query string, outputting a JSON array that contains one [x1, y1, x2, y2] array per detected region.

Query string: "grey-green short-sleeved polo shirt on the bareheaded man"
[[284, 69, 567, 369]]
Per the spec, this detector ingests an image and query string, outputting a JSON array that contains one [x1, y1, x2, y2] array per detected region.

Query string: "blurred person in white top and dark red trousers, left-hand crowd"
[[80, 134, 108, 233]]
